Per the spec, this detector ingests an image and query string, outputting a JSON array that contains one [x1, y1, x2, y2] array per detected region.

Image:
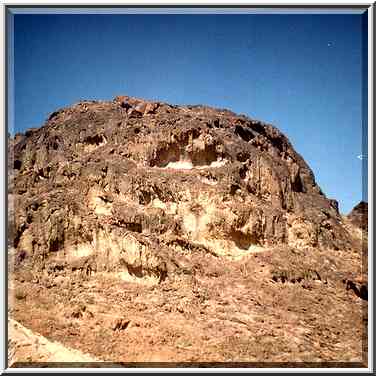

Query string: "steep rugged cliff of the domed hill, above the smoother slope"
[[10, 97, 350, 273]]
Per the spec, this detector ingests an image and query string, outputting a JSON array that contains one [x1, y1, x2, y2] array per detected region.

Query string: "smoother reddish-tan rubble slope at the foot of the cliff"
[[10, 244, 367, 367]]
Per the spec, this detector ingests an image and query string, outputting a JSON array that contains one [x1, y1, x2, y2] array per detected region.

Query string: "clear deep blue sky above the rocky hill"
[[9, 14, 367, 213]]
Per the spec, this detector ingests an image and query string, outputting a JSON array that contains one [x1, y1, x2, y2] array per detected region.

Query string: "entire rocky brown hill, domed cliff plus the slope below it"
[[8, 96, 365, 368]]
